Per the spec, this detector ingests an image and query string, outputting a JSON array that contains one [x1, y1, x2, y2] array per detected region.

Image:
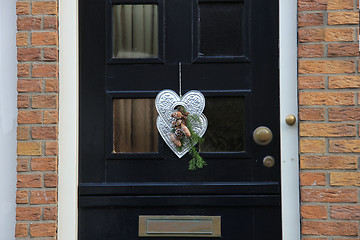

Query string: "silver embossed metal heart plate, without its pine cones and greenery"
[[155, 89, 208, 158]]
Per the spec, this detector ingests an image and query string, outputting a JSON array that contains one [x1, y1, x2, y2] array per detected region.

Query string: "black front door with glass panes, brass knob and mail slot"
[[79, 0, 281, 240]]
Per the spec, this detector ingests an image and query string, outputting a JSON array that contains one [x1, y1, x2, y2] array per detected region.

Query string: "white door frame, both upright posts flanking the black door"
[[58, 0, 300, 240]]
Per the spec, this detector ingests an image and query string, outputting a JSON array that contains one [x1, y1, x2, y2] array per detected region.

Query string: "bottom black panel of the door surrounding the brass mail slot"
[[79, 205, 281, 240]]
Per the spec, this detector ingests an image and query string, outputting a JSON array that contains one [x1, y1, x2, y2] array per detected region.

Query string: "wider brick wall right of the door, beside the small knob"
[[298, 0, 360, 240]]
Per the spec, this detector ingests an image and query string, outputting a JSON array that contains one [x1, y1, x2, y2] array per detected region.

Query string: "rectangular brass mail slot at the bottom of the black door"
[[139, 216, 221, 237]]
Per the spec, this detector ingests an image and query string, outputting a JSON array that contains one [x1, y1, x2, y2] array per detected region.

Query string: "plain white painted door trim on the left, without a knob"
[[58, 0, 79, 240]]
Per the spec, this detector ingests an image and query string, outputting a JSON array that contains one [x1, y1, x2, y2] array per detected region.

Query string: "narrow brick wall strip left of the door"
[[15, 0, 59, 239]]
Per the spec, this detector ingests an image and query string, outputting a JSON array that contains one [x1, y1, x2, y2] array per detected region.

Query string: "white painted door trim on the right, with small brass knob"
[[279, 0, 300, 240]]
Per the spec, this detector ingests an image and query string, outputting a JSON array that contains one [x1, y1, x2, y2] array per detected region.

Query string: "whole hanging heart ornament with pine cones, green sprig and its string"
[[155, 63, 208, 170]]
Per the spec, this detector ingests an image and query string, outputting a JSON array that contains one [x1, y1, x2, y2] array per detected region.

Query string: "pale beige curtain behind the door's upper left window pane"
[[113, 4, 158, 58]]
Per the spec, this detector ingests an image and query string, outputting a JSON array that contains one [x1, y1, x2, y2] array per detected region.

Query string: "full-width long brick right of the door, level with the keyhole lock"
[[300, 155, 357, 169]]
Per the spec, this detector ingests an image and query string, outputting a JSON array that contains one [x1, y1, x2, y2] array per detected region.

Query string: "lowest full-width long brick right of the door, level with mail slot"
[[301, 221, 359, 236]]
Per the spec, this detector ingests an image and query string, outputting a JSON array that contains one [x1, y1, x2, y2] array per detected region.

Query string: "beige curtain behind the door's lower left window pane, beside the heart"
[[113, 99, 158, 153]]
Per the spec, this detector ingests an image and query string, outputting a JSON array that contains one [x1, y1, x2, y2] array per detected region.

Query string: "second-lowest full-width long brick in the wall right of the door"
[[301, 189, 358, 203]]
